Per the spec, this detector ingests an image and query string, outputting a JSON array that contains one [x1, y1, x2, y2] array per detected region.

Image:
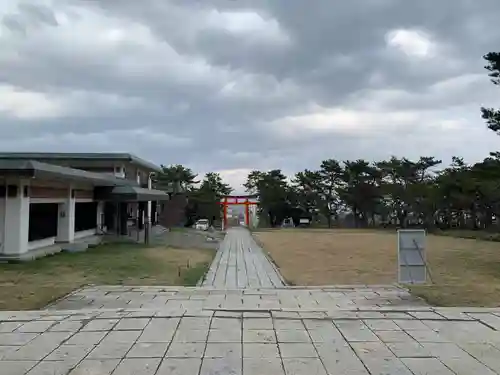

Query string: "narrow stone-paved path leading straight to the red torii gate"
[[203, 228, 284, 289]]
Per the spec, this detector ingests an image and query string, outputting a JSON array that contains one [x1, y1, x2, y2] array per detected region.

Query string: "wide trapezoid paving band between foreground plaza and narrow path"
[[48, 285, 426, 314]]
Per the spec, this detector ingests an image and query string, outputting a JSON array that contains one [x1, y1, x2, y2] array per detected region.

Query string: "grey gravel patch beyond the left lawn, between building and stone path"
[[151, 228, 224, 250]]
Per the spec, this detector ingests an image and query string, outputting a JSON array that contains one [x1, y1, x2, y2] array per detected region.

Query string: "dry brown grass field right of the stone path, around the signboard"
[[255, 229, 500, 306]]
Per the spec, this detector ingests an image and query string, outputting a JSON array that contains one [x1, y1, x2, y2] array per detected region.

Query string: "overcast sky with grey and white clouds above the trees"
[[0, 0, 500, 194]]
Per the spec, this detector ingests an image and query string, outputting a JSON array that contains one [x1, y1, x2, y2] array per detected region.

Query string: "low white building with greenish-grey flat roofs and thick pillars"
[[0, 153, 168, 260]]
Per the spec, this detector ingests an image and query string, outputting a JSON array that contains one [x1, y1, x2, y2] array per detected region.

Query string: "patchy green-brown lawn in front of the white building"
[[0, 244, 215, 310]]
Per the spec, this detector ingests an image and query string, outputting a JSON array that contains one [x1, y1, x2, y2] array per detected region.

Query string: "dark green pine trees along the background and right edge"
[[156, 52, 500, 230]]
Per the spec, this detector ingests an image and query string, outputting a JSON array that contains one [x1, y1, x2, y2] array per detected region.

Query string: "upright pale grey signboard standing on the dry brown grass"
[[398, 229, 427, 284]]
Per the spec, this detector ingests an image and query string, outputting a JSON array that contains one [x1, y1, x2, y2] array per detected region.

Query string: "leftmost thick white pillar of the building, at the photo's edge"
[[3, 181, 30, 255]]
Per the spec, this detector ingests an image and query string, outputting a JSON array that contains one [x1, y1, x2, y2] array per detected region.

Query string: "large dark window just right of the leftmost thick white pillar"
[[28, 203, 58, 241]]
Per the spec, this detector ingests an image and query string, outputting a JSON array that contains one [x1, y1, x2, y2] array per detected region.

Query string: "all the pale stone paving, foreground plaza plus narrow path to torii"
[[0, 230, 500, 375]]
